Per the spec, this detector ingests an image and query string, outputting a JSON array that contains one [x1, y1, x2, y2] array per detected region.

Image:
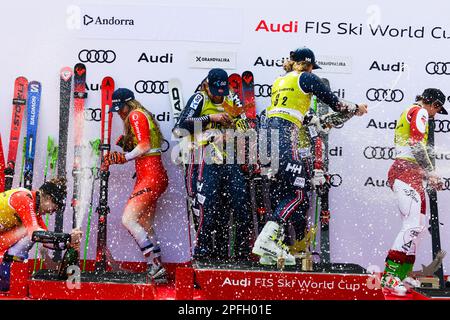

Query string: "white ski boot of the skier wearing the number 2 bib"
[[252, 221, 295, 265]]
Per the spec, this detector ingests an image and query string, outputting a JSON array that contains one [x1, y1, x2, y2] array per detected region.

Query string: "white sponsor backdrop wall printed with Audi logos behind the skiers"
[[0, 0, 450, 273]]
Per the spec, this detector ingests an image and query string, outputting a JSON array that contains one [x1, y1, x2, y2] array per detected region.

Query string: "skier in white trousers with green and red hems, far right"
[[381, 88, 448, 296]]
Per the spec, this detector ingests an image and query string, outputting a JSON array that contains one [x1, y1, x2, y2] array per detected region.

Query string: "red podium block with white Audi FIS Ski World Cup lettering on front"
[[193, 261, 384, 300]]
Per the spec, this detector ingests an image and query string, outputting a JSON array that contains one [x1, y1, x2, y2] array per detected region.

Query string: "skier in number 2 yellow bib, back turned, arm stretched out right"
[[252, 48, 367, 265]]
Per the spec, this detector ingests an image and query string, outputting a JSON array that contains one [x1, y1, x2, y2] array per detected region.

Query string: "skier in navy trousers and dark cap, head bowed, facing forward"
[[174, 69, 251, 261]]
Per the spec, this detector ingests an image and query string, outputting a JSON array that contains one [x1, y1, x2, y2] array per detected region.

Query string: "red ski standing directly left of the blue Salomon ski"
[[2, 77, 28, 190]]
